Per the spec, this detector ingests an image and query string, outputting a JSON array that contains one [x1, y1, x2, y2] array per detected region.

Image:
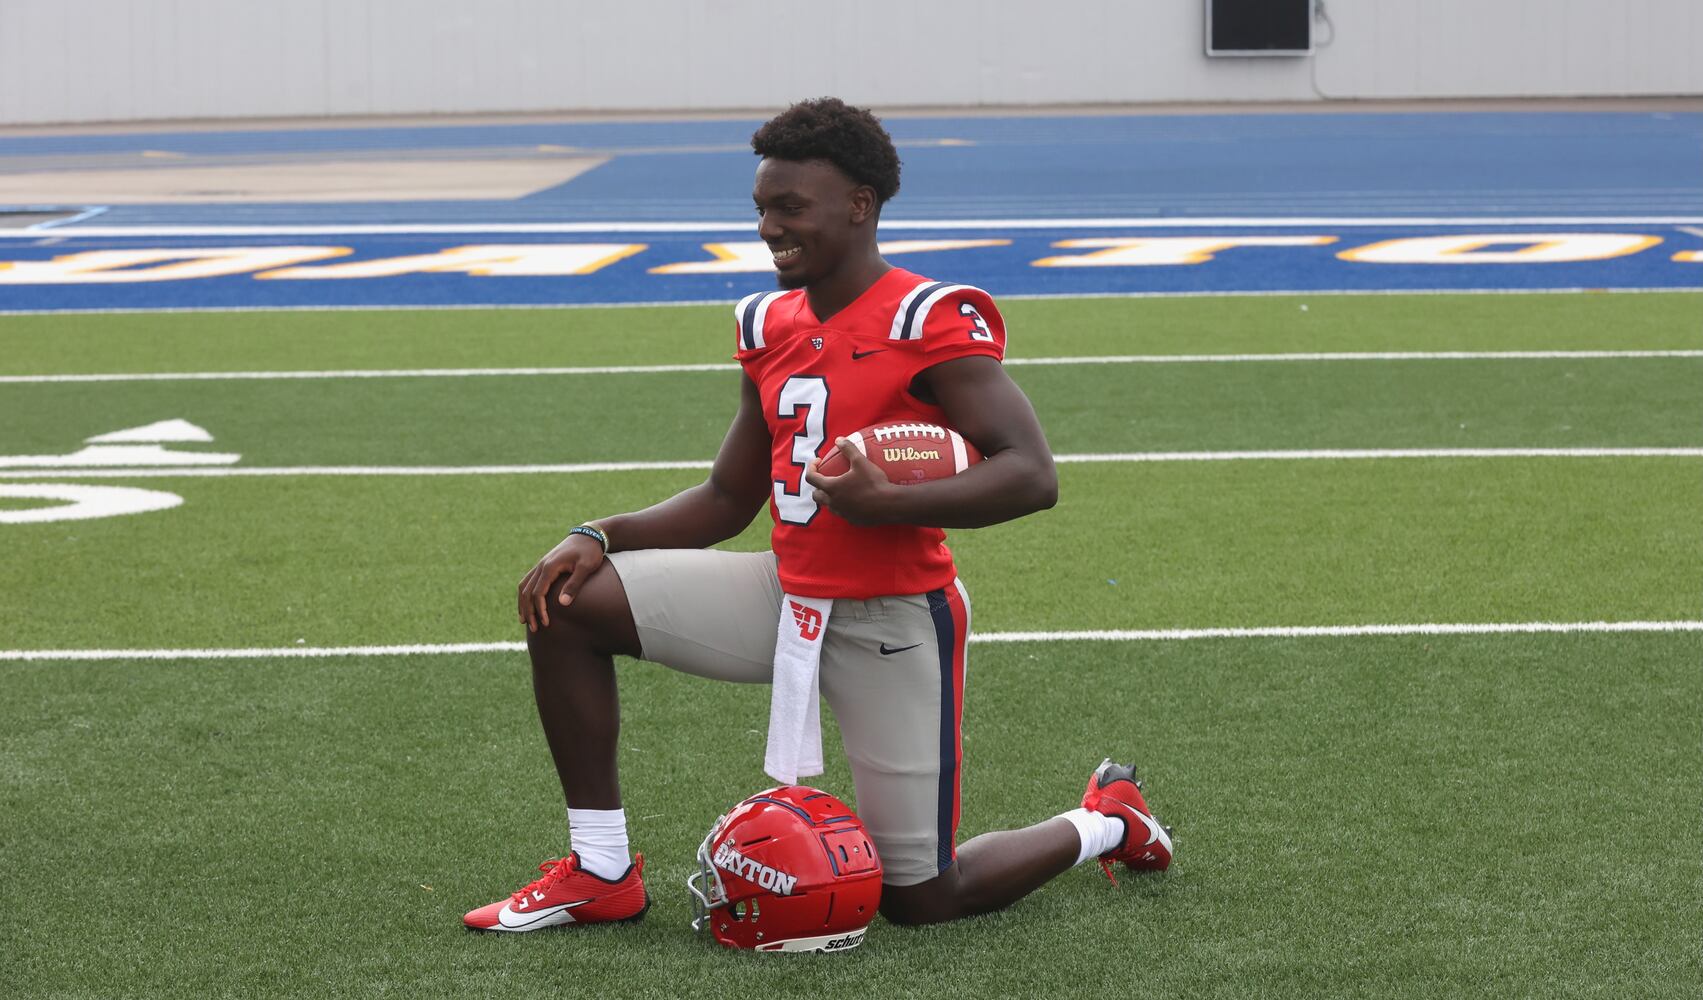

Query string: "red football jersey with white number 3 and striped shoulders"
[[734, 267, 1005, 598]]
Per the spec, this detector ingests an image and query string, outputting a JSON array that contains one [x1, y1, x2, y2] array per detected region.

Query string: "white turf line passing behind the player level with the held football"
[[0, 448, 1703, 480]]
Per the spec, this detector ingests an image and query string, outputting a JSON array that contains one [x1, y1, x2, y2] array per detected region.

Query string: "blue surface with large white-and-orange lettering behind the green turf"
[[0, 112, 1703, 312]]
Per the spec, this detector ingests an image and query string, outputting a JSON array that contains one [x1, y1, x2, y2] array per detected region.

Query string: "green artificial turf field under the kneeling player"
[[0, 293, 1703, 998]]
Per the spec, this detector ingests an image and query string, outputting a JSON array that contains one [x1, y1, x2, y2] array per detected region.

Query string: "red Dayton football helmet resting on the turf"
[[686, 785, 880, 952]]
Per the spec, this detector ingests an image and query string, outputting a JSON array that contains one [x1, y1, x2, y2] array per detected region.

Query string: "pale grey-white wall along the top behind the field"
[[0, 0, 1703, 124]]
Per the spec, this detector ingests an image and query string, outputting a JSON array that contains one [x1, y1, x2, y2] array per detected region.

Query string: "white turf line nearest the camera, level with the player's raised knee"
[[0, 622, 1703, 663]]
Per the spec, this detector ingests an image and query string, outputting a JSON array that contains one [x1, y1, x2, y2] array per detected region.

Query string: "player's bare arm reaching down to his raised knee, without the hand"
[[598, 378, 770, 550]]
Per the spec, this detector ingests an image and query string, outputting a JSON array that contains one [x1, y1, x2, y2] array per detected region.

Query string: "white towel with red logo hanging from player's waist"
[[763, 595, 834, 785]]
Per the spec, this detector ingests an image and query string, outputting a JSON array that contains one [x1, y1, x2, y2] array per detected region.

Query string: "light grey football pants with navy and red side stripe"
[[610, 549, 969, 886]]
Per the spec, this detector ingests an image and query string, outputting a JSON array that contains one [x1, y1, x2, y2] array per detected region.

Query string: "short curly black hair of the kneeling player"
[[751, 97, 899, 204]]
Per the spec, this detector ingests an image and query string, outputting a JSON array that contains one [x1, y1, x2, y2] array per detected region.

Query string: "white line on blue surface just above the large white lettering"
[[0, 215, 1703, 240]]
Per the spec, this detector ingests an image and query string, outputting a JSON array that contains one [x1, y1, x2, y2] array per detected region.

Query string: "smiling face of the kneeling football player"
[[751, 158, 875, 288]]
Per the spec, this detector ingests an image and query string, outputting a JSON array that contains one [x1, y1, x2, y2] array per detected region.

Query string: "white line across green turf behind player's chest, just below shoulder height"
[[0, 351, 1703, 385]]
